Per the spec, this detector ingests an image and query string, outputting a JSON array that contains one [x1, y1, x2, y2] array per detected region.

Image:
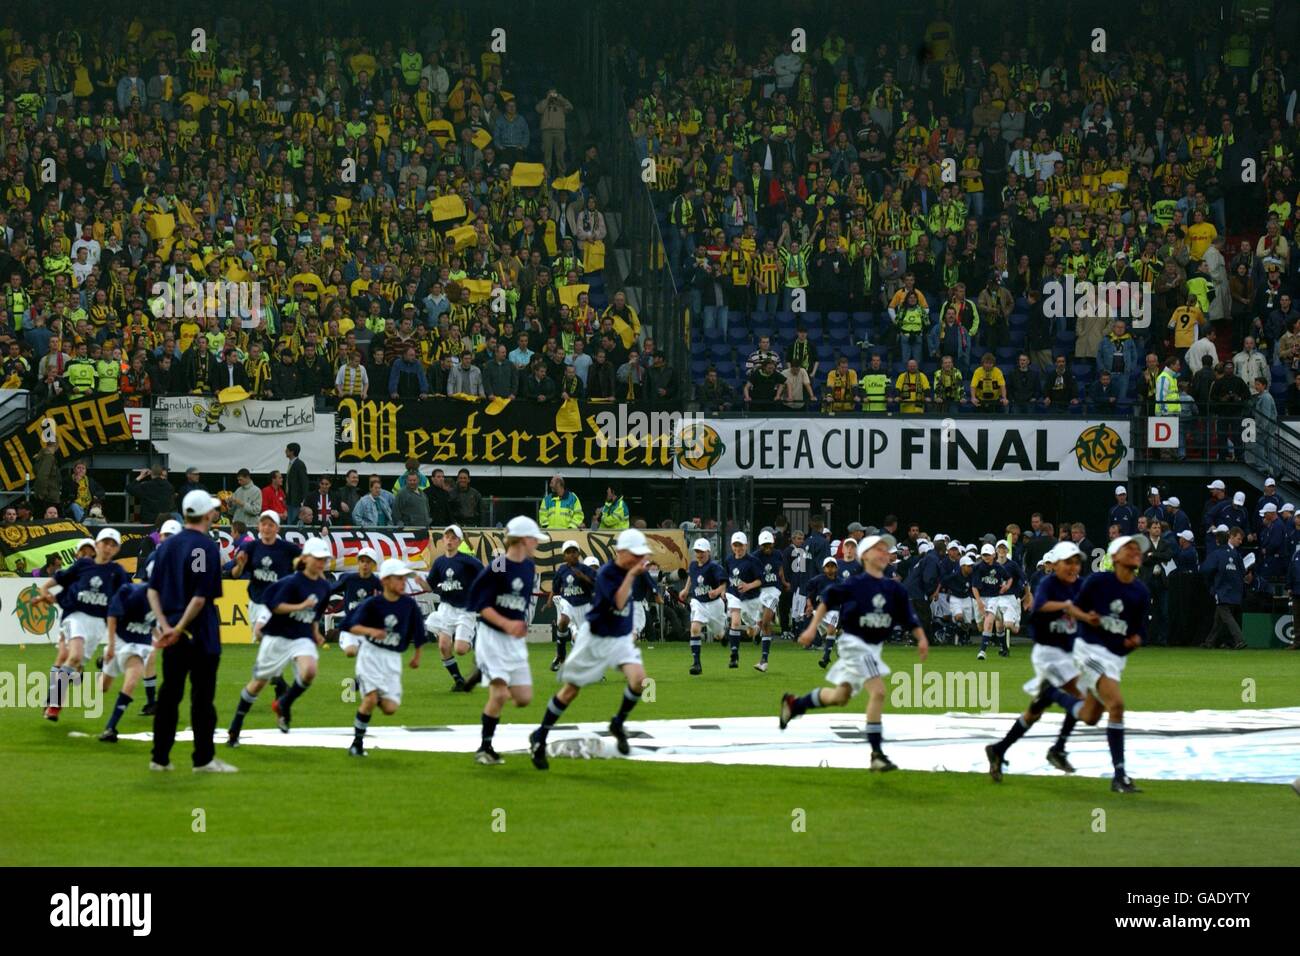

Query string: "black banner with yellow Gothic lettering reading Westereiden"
[[335, 398, 683, 475]]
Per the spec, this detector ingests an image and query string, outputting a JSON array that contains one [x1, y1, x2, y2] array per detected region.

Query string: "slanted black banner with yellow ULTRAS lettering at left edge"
[[0, 393, 131, 492]]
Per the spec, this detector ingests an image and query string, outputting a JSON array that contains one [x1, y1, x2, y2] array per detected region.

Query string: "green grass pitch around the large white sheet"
[[0, 644, 1300, 866]]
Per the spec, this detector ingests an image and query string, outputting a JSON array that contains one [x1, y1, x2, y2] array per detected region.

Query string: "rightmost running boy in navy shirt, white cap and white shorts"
[[1049, 535, 1151, 793]]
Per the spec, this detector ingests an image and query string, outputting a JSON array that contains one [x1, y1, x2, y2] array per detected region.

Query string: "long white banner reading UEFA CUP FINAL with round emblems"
[[675, 416, 1130, 481]]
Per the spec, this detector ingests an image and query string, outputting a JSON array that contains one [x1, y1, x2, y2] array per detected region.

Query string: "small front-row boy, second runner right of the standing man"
[[345, 558, 425, 757]]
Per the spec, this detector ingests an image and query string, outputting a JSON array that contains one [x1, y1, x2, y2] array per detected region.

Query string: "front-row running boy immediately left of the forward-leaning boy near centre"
[[467, 515, 546, 766]]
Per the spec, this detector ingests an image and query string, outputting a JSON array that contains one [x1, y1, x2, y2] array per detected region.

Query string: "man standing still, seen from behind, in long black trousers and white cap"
[[148, 489, 235, 774]]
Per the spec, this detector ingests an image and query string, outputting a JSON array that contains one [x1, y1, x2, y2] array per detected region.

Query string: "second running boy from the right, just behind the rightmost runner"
[[984, 541, 1100, 783]]
